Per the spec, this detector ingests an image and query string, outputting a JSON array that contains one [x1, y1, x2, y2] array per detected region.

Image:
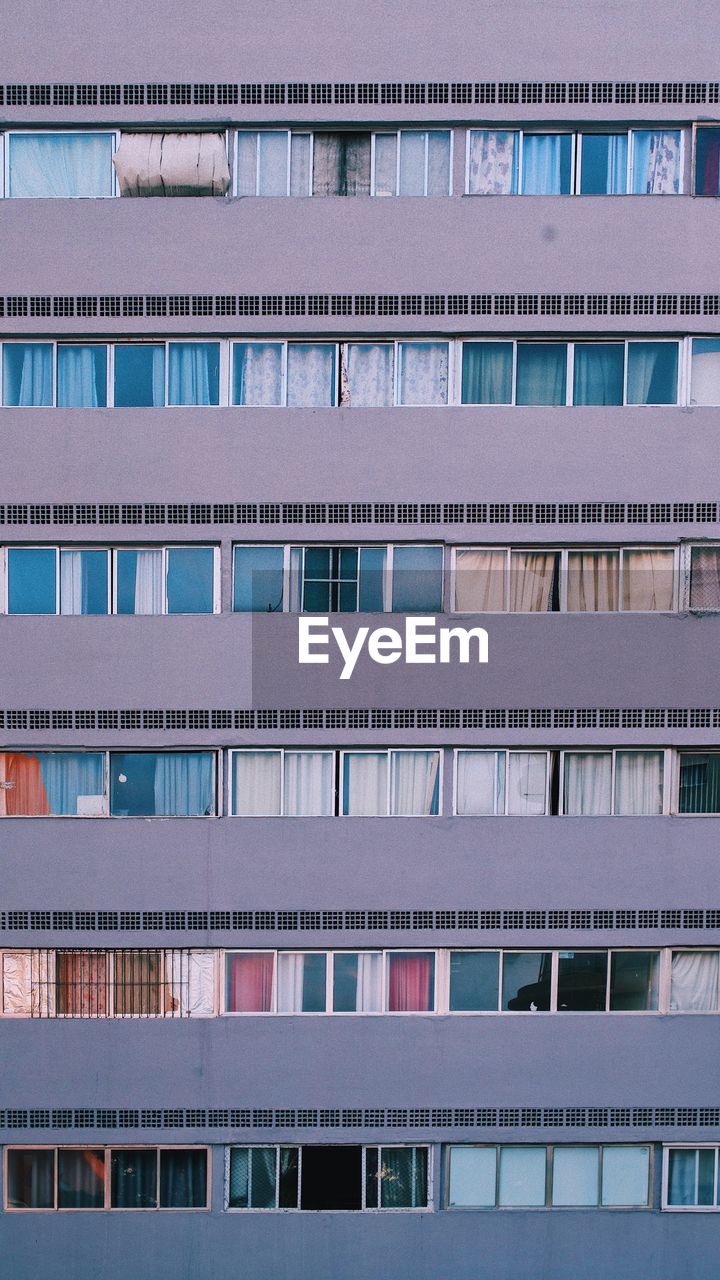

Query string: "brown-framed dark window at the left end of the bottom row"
[[5, 1147, 210, 1210]]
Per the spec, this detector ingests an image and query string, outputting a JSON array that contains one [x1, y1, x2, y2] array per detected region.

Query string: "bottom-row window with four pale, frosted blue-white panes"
[[447, 1144, 650, 1208]]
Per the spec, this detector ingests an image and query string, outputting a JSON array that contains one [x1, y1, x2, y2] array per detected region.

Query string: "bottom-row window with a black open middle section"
[[227, 1144, 429, 1211]]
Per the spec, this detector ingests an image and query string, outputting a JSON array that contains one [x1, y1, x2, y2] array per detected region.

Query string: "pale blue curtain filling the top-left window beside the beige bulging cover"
[[8, 133, 114, 197]]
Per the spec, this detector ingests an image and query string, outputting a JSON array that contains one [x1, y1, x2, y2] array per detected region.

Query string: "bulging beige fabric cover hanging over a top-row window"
[[113, 133, 231, 196]]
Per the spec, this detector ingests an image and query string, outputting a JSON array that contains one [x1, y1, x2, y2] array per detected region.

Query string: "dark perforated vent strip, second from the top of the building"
[[0, 293, 720, 320]]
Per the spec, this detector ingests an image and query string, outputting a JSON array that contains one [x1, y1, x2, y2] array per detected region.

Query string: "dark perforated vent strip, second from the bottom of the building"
[[0, 906, 720, 933]]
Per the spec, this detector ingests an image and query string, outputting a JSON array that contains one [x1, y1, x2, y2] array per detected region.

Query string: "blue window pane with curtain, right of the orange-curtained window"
[[110, 751, 214, 818]]
